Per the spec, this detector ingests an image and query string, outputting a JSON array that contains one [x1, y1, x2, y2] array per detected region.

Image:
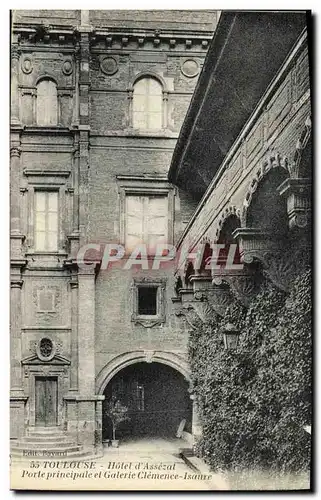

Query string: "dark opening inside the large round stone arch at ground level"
[[102, 362, 192, 440]]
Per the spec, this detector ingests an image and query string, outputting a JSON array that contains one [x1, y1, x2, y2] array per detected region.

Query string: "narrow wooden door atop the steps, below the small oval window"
[[36, 377, 58, 427]]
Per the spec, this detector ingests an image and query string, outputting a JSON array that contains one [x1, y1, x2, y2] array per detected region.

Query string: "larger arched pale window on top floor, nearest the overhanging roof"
[[133, 78, 163, 130]]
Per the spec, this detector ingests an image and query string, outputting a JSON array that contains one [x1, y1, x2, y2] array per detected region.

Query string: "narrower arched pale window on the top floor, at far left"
[[37, 80, 58, 126]]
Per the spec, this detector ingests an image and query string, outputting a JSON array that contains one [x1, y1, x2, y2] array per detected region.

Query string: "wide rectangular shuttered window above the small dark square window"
[[125, 195, 168, 253]]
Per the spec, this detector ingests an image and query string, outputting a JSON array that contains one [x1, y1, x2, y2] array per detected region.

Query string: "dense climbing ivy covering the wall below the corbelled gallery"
[[189, 271, 311, 470]]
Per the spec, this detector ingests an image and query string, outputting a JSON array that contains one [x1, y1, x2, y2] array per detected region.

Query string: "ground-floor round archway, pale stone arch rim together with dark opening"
[[97, 351, 195, 440]]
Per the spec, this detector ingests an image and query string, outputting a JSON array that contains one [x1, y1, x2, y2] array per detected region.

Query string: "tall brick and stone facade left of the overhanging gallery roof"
[[10, 10, 219, 456]]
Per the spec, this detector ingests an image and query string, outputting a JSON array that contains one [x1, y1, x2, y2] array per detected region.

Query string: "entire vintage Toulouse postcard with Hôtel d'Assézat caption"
[[10, 9, 312, 491]]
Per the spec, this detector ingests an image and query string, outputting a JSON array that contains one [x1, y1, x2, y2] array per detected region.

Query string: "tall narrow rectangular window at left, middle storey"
[[35, 191, 58, 252]]
